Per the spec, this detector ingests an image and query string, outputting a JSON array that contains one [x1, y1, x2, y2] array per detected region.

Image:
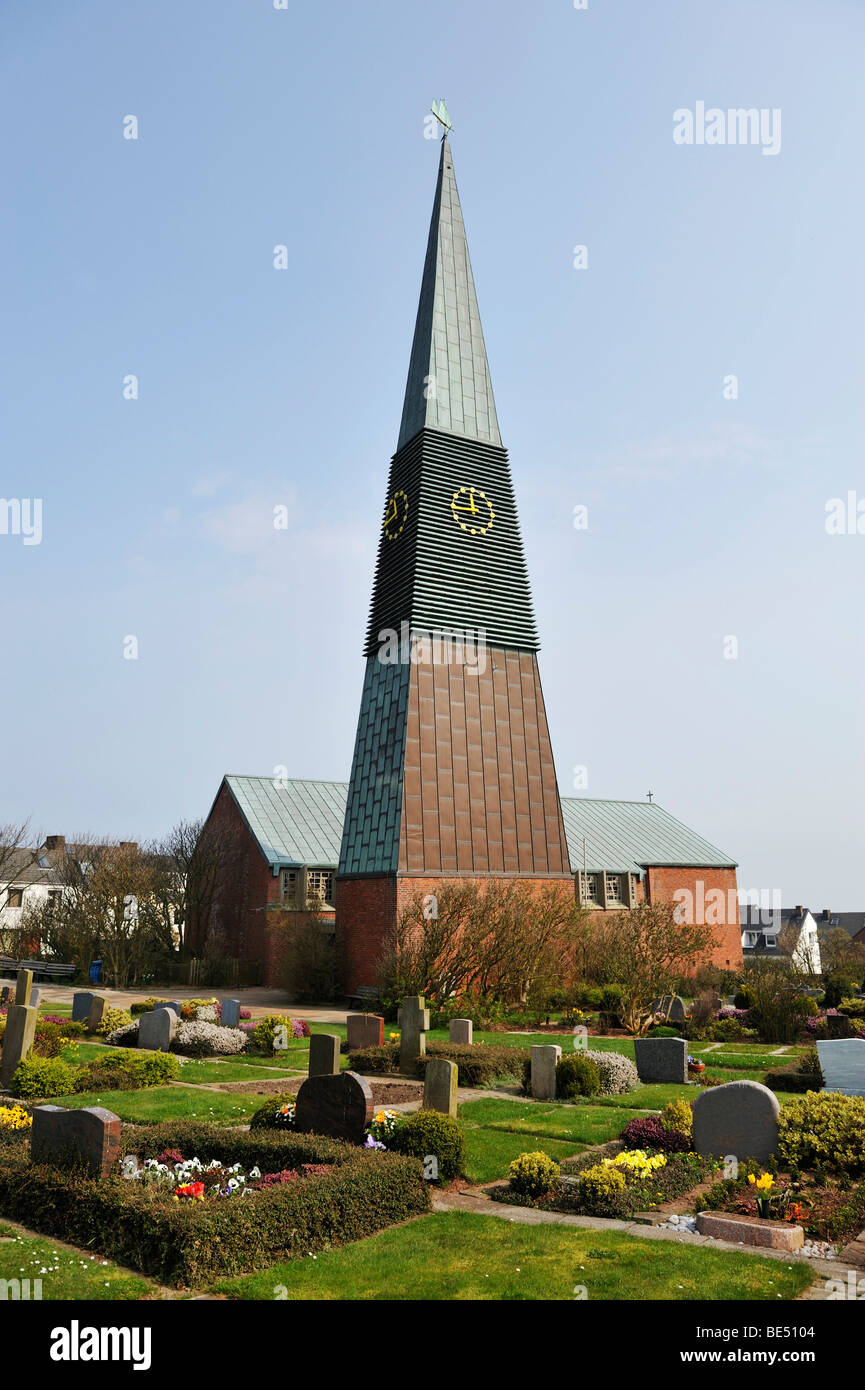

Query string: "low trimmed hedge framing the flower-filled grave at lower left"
[[0, 1123, 430, 1289]]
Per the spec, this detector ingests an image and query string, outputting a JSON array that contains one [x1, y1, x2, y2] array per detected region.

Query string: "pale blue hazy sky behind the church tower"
[[0, 0, 865, 909]]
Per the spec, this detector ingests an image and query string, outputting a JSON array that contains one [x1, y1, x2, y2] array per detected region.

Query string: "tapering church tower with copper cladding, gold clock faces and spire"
[[337, 131, 573, 994]]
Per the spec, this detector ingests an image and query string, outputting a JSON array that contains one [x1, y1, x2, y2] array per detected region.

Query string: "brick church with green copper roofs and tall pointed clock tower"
[[193, 129, 741, 995]]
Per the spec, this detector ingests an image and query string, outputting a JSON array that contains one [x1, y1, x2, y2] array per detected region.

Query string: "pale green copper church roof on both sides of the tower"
[[225, 774, 736, 873]]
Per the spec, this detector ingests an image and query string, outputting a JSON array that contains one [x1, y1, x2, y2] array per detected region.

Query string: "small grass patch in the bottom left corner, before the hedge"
[[0, 1227, 152, 1302]]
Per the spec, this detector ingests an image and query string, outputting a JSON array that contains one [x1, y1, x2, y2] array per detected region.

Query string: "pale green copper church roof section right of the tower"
[[562, 796, 736, 873]]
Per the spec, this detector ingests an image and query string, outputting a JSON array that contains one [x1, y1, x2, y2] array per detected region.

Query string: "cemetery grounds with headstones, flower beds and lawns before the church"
[[0, 972, 865, 1298]]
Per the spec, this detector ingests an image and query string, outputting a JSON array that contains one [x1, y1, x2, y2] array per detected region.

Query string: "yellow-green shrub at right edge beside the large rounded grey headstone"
[[777, 1091, 865, 1176]]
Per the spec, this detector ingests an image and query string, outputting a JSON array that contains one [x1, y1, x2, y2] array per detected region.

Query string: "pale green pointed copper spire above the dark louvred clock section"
[[396, 135, 502, 449]]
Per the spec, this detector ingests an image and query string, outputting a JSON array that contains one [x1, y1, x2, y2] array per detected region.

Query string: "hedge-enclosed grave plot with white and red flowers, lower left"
[[0, 1100, 430, 1287]]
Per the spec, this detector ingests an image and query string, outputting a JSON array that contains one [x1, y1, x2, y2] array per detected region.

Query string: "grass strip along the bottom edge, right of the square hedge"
[[214, 1212, 814, 1302]]
